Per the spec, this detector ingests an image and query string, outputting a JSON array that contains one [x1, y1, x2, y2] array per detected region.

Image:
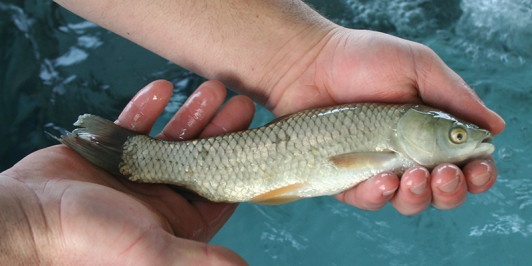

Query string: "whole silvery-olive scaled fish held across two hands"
[[60, 103, 495, 204]]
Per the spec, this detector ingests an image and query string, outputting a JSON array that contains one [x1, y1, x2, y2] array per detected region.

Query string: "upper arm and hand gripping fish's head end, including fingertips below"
[[57, 0, 504, 214]]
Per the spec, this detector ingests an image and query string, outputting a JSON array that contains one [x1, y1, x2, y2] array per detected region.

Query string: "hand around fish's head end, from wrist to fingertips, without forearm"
[[257, 27, 504, 215]]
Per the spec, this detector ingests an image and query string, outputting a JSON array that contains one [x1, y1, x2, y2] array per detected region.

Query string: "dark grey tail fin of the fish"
[[59, 114, 138, 176]]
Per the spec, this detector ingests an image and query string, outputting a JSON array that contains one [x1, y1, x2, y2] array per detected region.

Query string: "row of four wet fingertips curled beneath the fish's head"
[[335, 159, 497, 215]]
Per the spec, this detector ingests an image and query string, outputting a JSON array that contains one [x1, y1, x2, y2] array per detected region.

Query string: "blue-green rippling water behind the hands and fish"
[[0, 0, 532, 265]]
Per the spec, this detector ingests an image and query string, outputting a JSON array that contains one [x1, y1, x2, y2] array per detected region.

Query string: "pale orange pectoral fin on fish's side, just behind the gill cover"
[[329, 151, 398, 169]]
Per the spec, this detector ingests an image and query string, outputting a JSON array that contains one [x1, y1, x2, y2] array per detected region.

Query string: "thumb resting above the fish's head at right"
[[411, 43, 505, 134]]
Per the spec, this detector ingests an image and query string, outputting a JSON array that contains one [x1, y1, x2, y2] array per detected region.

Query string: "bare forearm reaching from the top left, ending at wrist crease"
[[55, 0, 338, 108]]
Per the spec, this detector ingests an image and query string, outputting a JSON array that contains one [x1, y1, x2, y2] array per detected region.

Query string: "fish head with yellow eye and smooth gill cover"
[[396, 105, 495, 167]]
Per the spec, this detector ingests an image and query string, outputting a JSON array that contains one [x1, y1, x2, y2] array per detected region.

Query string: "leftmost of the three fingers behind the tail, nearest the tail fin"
[[115, 80, 172, 134]]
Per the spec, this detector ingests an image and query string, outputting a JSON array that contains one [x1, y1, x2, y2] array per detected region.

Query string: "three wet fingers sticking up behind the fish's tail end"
[[116, 80, 255, 140]]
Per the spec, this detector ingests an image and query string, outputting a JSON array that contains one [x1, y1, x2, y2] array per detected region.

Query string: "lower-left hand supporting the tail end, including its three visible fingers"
[[0, 81, 254, 265]]
